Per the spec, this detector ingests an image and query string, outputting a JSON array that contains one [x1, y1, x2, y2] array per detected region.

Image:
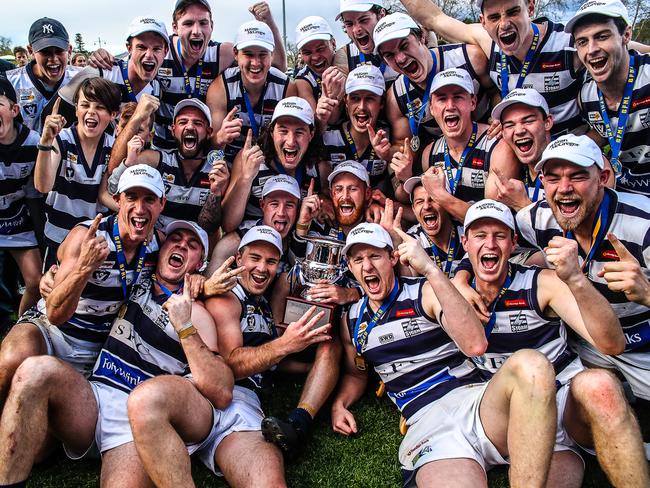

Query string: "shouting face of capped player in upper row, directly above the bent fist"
[[429, 85, 476, 139]]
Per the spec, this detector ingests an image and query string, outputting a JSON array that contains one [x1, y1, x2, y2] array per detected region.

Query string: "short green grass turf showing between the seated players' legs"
[[29, 379, 650, 488]]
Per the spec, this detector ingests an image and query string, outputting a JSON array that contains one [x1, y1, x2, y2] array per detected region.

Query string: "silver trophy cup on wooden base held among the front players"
[[283, 236, 345, 327]]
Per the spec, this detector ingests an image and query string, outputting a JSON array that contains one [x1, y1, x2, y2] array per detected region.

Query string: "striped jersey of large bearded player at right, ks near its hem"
[[517, 188, 650, 352]]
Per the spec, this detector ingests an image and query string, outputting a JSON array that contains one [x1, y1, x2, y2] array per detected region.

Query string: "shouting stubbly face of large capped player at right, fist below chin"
[[542, 159, 610, 230]]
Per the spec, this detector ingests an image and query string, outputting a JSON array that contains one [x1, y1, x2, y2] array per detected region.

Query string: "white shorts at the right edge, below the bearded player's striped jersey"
[[572, 339, 650, 401]]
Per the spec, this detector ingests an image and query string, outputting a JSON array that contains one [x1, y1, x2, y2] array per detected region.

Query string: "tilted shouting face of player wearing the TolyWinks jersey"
[[156, 229, 203, 284]]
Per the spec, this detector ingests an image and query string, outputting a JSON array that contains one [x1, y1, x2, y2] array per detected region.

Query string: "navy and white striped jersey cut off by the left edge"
[[0, 124, 40, 248]]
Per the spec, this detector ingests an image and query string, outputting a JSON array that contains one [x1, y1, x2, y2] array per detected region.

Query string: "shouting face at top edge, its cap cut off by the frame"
[[480, 0, 534, 56]]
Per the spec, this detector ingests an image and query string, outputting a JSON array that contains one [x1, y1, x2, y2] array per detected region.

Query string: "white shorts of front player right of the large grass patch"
[[399, 382, 508, 486]]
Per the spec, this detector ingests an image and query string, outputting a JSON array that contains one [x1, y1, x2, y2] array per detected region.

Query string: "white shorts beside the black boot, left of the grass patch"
[[197, 386, 264, 476]]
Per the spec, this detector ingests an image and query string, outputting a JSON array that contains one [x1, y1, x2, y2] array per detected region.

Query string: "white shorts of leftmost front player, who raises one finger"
[[18, 300, 102, 378]]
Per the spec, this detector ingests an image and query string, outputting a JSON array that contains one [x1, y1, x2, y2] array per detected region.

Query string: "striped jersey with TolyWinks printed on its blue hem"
[[89, 280, 190, 393]]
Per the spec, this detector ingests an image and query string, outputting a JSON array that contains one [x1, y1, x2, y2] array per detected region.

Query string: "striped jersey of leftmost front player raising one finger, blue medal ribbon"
[[59, 215, 160, 346]]
